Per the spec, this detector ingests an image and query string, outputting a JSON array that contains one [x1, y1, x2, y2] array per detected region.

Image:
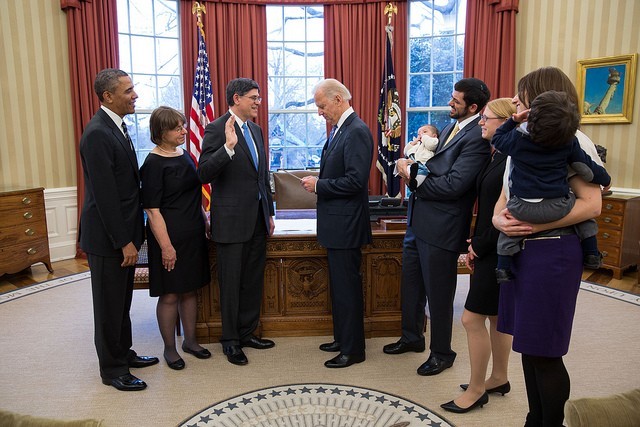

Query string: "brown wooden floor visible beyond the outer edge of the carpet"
[[0, 259, 640, 295]]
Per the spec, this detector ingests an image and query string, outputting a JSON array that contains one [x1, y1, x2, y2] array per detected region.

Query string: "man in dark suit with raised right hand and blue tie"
[[198, 78, 275, 365]]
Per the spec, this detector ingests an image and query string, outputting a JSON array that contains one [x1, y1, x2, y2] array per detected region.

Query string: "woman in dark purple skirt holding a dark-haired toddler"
[[493, 67, 602, 426]]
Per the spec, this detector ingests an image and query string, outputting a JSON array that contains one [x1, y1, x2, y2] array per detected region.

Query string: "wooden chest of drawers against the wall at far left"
[[0, 188, 53, 276]]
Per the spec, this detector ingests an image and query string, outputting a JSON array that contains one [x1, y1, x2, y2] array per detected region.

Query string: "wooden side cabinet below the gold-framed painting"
[[596, 193, 640, 279]]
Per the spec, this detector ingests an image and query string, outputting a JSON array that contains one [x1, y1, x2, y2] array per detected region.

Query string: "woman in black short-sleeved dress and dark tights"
[[140, 107, 211, 370]]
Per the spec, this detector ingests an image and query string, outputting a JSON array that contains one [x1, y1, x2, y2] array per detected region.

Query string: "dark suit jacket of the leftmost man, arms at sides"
[[78, 108, 144, 257]]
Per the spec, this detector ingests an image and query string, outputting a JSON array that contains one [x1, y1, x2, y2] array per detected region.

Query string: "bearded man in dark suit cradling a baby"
[[383, 78, 490, 375]]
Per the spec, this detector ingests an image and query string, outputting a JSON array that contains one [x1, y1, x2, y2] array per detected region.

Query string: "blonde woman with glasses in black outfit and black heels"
[[441, 98, 516, 413]]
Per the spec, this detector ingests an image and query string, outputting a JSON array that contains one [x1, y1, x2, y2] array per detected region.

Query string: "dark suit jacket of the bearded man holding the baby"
[[407, 118, 490, 252]]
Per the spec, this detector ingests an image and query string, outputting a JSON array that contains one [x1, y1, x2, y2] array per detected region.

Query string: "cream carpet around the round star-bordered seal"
[[0, 273, 640, 426]]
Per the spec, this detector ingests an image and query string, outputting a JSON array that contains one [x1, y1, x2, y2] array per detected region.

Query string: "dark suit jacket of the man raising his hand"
[[198, 112, 274, 243]]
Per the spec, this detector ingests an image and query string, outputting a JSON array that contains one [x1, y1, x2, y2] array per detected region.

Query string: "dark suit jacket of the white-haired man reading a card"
[[316, 113, 373, 249]]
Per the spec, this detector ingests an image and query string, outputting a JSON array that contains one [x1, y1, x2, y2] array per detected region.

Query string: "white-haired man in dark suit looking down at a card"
[[301, 79, 373, 368]]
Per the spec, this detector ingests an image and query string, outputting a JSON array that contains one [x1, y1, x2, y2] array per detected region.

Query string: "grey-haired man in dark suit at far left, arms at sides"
[[78, 68, 158, 390]]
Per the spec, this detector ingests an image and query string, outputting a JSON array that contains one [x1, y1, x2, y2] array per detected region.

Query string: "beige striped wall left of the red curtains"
[[0, 0, 76, 188]]
